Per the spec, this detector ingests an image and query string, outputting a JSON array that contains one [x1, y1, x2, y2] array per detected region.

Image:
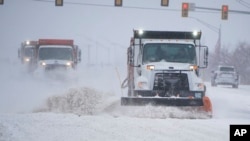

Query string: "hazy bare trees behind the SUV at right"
[[205, 42, 250, 85]]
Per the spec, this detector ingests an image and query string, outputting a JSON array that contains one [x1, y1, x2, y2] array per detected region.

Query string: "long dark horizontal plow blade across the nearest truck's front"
[[121, 97, 205, 106]]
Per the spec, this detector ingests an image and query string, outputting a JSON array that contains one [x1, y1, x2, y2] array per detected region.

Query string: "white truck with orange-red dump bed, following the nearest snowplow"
[[36, 39, 81, 71]]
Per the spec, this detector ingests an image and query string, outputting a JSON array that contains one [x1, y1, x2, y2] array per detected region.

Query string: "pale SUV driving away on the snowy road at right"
[[211, 66, 239, 88]]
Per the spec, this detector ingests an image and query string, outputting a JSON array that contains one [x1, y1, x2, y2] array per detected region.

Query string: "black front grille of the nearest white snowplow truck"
[[153, 73, 189, 96]]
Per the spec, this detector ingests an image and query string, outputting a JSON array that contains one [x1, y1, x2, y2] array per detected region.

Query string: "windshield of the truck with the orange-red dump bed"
[[39, 46, 73, 60]]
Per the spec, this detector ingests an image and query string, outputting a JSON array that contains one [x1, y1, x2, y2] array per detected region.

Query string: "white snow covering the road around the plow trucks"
[[0, 59, 250, 141]]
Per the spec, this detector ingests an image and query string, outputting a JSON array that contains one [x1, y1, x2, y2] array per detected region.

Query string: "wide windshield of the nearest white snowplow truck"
[[142, 43, 196, 64]]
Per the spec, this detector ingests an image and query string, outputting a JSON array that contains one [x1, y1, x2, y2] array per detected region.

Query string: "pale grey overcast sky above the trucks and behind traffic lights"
[[0, 0, 250, 64]]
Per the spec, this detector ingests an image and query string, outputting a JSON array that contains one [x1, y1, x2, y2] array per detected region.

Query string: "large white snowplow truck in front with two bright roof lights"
[[121, 30, 212, 112]]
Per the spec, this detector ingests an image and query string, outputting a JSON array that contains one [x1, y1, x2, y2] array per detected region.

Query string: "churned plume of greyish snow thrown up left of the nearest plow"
[[36, 87, 103, 115]]
